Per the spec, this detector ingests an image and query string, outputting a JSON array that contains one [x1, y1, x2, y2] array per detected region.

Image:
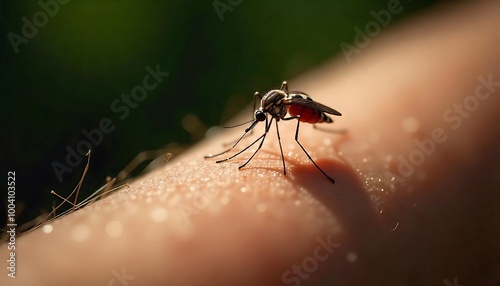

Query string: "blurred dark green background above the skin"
[[0, 0, 436, 228]]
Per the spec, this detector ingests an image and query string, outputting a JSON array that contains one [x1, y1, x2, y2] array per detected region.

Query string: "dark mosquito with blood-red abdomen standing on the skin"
[[205, 81, 342, 183]]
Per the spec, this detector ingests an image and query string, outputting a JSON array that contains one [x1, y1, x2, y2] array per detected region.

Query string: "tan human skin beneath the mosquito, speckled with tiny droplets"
[[0, 1, 500, 285]]
